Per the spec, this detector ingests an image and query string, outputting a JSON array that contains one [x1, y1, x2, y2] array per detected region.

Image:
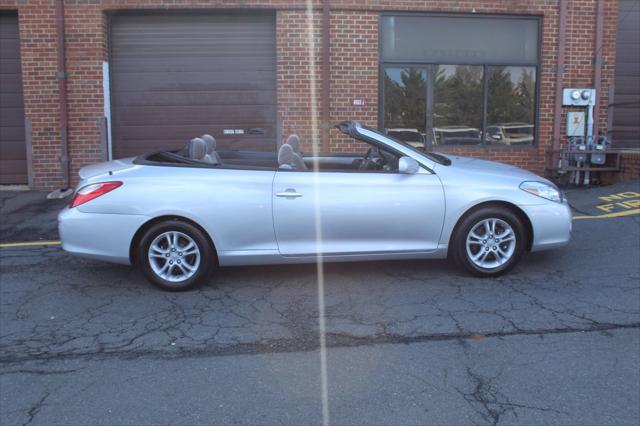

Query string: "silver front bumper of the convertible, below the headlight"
[[520, 201, 572, 251]]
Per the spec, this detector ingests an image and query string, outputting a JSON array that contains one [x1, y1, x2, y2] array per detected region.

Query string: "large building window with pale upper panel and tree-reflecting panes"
[[380, 14, 540, 148]]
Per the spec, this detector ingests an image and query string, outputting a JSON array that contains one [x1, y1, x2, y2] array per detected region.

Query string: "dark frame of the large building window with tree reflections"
[[378, 12, 543, 150]]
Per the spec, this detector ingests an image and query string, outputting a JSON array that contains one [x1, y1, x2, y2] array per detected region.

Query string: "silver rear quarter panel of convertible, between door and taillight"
[[77, 166, 278, 250]]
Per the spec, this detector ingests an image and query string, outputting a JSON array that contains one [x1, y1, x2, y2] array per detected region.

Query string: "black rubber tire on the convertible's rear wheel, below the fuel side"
[[136, 220, 215, 291]]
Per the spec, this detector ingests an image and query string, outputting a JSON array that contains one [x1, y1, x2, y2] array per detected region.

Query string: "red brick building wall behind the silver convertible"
[[0, 0, 617, 188]]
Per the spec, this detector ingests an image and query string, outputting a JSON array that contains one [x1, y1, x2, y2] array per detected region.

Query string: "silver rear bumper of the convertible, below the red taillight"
[[58, 207, 150, 265]]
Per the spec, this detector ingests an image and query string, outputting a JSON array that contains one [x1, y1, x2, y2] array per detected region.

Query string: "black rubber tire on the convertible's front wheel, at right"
[[449, 206, 528, 277]]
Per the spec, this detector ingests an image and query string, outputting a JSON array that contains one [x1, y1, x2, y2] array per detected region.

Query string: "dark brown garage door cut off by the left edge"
[[0, 13, 27, 184]]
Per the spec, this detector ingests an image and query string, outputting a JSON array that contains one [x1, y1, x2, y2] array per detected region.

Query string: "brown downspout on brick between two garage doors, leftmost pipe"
[[56, 0, 70, 191]]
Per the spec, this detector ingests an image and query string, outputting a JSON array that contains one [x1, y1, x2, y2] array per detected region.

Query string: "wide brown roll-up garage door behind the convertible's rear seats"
[[110, 14, 276, 158]]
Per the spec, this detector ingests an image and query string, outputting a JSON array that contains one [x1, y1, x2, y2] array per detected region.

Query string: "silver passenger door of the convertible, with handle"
[[273, 168, 445, 256]]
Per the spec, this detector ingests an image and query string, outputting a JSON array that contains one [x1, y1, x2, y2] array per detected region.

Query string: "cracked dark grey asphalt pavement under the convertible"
[[0, 183, 640, 425]]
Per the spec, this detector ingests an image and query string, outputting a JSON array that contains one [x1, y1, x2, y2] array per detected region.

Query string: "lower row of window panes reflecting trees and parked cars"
[[383, 65, 536, 147]]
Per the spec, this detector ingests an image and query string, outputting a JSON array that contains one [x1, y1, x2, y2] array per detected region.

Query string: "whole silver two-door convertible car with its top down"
[[58, 121, 571, 290]]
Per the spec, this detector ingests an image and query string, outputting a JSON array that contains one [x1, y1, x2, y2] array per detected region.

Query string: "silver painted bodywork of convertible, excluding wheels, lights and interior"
[[58, 120, 571, 266]]
